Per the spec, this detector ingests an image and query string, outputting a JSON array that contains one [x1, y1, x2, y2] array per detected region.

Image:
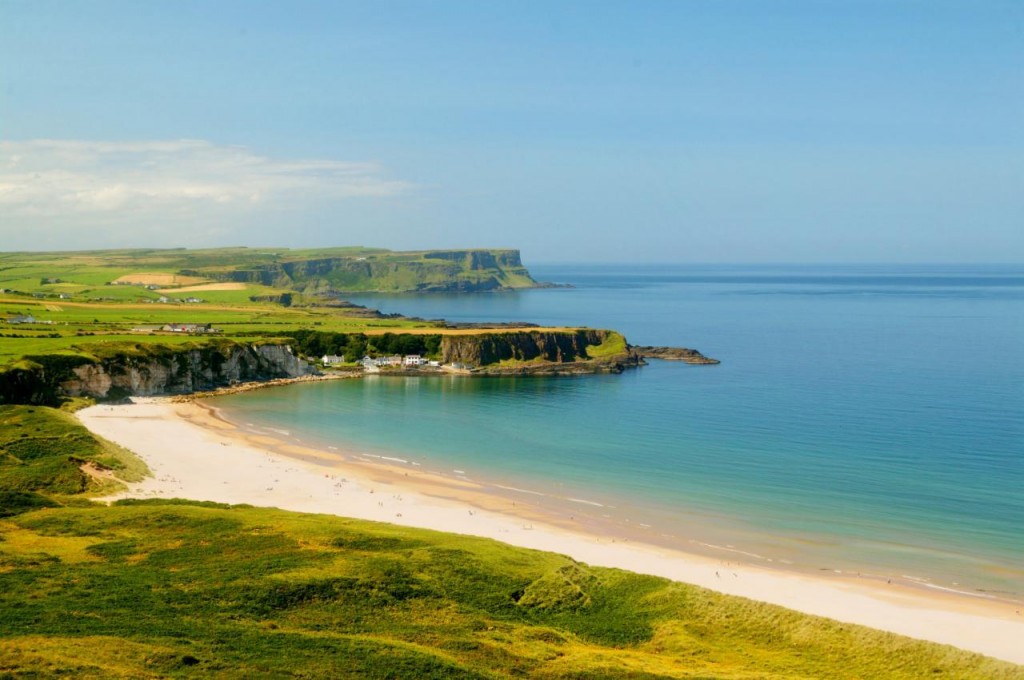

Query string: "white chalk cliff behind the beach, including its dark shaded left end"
[[0, 341, 313, 405]]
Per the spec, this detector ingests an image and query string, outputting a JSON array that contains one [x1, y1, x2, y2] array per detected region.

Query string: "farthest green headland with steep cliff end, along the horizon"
[[0, 247, 537, 300]]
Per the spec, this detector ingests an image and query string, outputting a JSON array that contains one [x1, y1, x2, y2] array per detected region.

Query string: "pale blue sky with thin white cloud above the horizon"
[[0, 0, 1024, 264]]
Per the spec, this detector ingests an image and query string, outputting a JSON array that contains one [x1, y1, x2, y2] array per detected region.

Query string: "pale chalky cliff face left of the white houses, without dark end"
[[59, 345, 312, 398]]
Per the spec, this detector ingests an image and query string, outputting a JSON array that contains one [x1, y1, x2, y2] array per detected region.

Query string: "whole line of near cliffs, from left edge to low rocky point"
[[0, 329, 717, 405]]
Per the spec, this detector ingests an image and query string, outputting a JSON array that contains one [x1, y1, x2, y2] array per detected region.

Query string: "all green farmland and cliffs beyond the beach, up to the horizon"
[[0, 248, 639, 406]]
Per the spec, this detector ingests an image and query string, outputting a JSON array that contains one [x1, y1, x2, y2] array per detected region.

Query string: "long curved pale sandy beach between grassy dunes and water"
[[78, 399, 1024, 664]]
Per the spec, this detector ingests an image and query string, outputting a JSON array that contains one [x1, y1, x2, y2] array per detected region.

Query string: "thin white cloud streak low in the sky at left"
[[0, 139, 412, 250]]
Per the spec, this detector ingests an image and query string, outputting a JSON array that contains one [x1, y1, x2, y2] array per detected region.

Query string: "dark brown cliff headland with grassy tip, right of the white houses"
[[440, 329, 640, 373]]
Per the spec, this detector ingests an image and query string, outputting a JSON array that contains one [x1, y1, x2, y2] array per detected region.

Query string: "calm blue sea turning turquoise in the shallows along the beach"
[[211, 265, 1024, 598]]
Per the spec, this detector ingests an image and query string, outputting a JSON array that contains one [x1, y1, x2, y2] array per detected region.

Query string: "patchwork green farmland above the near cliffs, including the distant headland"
[[0, 248, 552, 368]]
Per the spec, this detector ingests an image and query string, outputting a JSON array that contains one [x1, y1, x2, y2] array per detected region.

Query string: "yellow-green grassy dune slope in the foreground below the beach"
[[0, 407, 1024, 679]]
